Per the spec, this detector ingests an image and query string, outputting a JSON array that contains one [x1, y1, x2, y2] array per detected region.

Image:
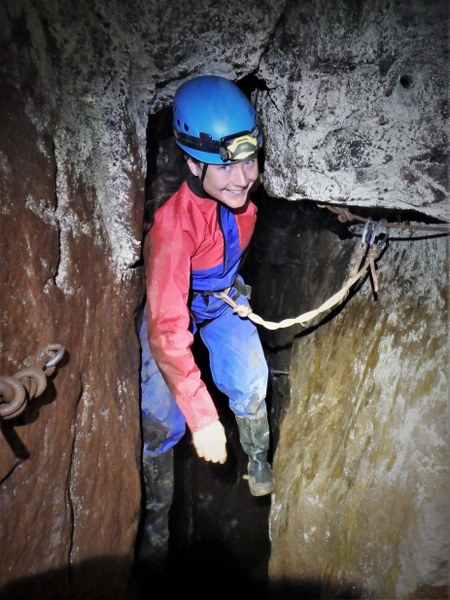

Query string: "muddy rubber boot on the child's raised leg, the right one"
[[236, 414, 275, 496]]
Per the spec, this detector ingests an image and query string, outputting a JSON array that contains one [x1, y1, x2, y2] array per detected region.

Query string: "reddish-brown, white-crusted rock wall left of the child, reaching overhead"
[[0, 0, 280, 600]]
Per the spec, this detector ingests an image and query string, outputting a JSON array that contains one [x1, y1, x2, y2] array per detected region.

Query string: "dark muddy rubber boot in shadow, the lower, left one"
[[138, 449, 174, 573]]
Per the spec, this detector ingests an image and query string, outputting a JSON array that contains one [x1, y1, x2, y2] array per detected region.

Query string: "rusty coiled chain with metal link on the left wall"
[[0, 344, 65, 419]]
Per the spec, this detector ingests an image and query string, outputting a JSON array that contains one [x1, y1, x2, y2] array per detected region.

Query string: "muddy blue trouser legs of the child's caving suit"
[[140, 297, 268, 456]]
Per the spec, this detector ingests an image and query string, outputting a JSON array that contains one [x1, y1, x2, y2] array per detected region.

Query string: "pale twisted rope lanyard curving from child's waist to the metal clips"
[[214, 244, 379, 330]]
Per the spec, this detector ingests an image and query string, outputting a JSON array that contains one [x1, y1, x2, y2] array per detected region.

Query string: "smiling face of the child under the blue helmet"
[[188, 158, 259, 209]]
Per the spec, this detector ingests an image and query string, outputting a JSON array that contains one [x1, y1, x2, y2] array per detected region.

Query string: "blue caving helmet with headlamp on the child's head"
[[173, 75, 263, 165]]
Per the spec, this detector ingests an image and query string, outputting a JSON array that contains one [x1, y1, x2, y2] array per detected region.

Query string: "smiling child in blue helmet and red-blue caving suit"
[[140, 75, 274, 564]]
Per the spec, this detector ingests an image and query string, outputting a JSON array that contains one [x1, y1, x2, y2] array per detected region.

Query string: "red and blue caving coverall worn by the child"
[[141, 173, 268, 453]]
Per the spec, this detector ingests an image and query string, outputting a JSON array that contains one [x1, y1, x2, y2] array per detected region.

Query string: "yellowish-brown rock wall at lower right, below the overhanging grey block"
[[246, 199, 450, 600]]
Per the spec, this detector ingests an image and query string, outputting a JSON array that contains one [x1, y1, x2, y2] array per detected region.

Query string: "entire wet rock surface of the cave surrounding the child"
[[0, 0, 448, 600]]
